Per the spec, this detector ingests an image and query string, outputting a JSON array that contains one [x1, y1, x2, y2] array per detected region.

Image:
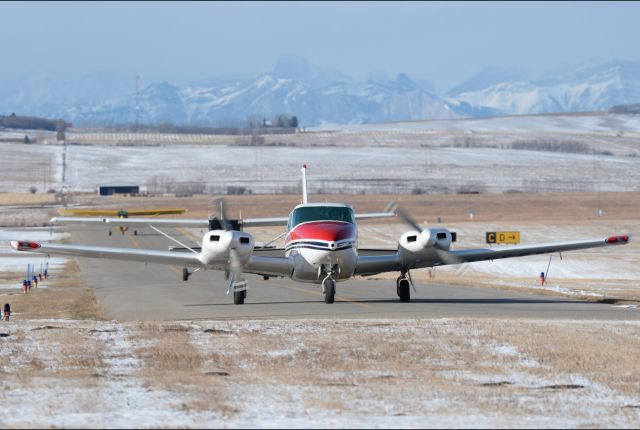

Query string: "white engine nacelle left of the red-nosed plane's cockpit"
[[201, 230, 255, 268]]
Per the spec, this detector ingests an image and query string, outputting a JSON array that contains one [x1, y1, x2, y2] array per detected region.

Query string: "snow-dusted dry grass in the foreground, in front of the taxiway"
[[0, 315, 640, 428]]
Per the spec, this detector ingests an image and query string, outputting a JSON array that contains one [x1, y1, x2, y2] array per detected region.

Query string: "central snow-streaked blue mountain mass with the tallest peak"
[[31, 60, 457, 126]]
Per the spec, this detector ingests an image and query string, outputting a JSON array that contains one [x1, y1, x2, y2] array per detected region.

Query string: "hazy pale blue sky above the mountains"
[[0, 1, 640, 91]]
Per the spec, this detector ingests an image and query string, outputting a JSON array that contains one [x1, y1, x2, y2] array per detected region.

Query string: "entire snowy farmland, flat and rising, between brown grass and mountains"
[[0, 115, 640, 194]]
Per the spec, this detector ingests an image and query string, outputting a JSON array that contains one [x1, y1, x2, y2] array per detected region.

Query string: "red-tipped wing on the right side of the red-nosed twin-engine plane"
[[354, 236, 629, 276]]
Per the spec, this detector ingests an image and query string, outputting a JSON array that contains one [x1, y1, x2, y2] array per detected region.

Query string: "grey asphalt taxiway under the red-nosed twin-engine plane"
[[65, 227, 640, 321]]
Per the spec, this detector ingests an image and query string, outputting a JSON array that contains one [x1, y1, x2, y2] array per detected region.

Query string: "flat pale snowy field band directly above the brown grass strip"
[[0, 144, 640, 194]]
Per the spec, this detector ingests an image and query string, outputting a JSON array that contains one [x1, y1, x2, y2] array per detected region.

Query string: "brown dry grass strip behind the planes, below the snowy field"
[[56, 192, 640, 225]]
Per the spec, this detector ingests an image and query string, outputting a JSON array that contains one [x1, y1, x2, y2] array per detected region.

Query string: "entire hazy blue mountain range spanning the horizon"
[[0, 58, 640, 127]]
